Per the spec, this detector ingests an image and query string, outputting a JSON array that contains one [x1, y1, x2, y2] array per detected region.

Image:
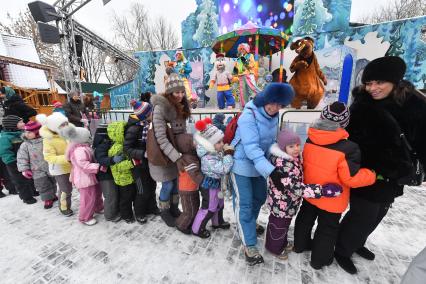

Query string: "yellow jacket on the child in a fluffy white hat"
[[40, 126, 71, 176]]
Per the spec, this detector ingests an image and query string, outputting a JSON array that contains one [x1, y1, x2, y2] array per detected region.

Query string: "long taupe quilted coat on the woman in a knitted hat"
[[149, 95, 186, 182]]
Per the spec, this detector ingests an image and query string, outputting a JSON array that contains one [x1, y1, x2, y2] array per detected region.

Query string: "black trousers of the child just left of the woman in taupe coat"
[[133, 168, 157, 217]]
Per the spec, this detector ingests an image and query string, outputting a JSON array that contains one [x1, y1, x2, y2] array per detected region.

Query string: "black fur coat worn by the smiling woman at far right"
[[347, 90, 426, 202]]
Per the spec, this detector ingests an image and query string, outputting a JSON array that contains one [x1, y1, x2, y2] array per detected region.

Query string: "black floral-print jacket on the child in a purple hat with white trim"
[[266, 143, 321, 218]]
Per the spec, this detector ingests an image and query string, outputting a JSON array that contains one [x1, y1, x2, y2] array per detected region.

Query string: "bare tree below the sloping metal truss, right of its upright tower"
[[82, 42, 106, 83]]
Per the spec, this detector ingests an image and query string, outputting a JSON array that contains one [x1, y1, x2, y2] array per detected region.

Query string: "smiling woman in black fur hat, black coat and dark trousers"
[[335, 56, 426, 274]]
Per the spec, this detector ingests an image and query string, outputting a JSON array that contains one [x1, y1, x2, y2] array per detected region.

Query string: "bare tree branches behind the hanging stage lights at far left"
[[0, 9, 62, 77]]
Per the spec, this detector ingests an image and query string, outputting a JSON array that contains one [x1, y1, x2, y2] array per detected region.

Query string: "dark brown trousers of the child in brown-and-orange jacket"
[[176, 190, 200, 230]]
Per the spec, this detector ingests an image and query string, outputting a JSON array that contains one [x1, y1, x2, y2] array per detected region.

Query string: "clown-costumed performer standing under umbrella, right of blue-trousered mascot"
[[234, 43, 260, 107]]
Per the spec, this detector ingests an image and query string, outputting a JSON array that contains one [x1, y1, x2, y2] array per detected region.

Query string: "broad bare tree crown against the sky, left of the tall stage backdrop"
[[113, 3, 178, 52]]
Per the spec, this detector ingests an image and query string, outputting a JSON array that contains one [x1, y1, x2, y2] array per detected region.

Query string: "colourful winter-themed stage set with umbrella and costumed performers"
[[110, 0, 426, 108]]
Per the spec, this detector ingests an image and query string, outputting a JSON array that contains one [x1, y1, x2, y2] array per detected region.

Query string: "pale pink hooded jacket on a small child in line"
[[65, 143, 99, 189]]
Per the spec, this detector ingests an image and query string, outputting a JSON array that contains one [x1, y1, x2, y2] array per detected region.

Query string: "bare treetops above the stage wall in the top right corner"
[[357, 0, 426, 24]]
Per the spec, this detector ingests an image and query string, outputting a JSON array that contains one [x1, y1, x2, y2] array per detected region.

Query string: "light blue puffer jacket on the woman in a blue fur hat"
[[231, 101, 278, 178]]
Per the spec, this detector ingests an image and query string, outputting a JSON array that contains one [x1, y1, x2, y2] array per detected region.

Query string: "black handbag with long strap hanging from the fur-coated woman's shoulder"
[[385, 110, 425, 186]]
